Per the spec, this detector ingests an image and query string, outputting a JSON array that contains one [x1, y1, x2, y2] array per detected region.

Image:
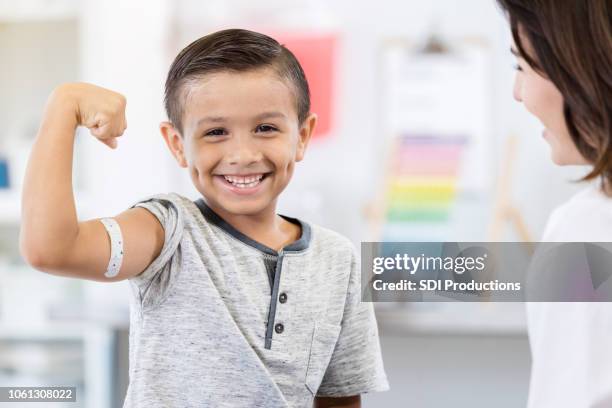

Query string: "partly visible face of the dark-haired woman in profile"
[[512, 37, 588, 165]]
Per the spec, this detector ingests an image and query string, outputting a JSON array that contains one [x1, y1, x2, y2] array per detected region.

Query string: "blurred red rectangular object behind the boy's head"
[[272, 34, 337, 139]]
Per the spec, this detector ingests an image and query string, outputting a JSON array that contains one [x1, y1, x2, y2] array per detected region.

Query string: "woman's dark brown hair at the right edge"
[[498, 0, 612, 194]]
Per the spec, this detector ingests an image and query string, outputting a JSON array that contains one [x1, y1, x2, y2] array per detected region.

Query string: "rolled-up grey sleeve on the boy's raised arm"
[[130, 194, 183, 308]]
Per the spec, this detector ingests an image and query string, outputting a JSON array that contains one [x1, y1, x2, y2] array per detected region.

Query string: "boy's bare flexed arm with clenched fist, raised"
[[19, 83, 164, 281]]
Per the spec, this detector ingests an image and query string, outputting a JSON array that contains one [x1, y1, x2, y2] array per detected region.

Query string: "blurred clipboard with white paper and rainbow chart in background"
[[367, 34, 491, 241]]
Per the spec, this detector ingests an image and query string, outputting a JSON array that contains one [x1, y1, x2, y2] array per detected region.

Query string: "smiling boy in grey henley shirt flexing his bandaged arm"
[[20, 30, 388, 407]]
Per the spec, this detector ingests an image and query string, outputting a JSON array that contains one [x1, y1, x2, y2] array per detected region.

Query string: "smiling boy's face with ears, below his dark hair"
[[161, 69, 316, 216]]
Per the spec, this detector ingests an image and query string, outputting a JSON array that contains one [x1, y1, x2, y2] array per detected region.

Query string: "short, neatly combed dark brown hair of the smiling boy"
[[164, 29, 310, 135]]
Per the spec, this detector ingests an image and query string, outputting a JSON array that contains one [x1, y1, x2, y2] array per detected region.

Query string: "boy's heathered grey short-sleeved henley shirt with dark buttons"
[[124, 193, 389, 408]]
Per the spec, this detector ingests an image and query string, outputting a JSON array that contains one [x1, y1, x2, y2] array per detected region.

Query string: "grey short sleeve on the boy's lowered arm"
[[317, 248, 389, 397]]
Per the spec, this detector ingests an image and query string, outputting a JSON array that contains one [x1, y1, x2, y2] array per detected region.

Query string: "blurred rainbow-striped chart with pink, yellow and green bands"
[[383, 135, 468, 241]]
